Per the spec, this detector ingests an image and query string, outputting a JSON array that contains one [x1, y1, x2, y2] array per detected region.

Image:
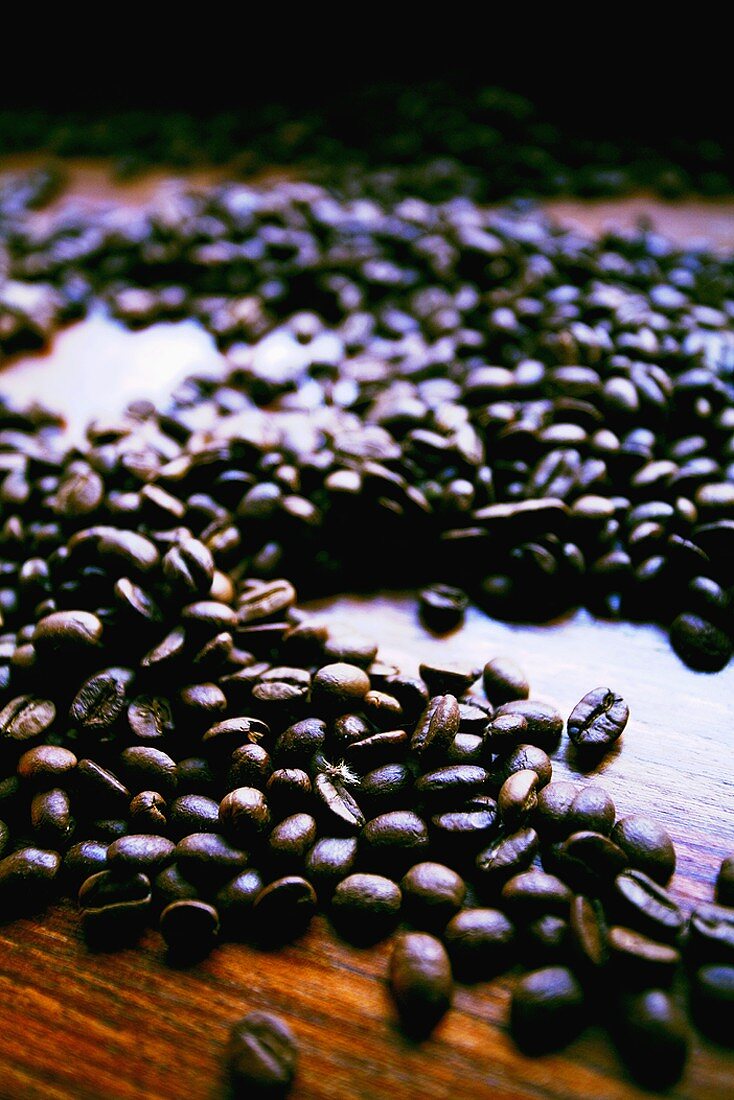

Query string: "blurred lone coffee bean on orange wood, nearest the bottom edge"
[[227, 1012, 298, 1097]]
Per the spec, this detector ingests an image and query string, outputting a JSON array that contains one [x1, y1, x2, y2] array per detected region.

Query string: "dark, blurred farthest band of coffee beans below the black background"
[[0, 83, 734, 201]]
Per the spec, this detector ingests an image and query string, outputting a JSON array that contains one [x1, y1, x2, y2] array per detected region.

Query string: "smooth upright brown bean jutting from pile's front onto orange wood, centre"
[[390, 932, 453, 1036]]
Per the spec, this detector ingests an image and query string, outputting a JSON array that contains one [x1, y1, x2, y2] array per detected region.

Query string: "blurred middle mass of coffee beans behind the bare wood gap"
[[0, 176, 734, 670]]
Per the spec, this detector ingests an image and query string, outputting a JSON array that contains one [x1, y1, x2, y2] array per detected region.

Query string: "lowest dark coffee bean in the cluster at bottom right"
[[613, 989, 688, 1089]]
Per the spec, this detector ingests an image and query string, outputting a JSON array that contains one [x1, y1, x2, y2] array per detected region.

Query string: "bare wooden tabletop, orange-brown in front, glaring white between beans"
[[0, 165, 734, 1100]]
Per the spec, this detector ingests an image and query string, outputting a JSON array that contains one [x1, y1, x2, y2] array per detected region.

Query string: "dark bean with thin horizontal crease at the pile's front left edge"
[[79, 869, 152, 947]]
